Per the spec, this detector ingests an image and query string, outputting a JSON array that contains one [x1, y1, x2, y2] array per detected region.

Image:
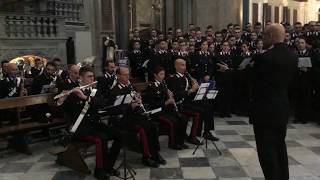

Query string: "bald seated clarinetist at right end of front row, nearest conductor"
[[167, 59, 219, 145]]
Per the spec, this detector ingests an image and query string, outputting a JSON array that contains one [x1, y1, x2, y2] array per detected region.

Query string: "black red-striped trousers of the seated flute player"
[[76, 123, 122, 170]]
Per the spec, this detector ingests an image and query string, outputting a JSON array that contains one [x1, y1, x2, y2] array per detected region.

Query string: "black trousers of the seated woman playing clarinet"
[[156, 111, 188, 145]]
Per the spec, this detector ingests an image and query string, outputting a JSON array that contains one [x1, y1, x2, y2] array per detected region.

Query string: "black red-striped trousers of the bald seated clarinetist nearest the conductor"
[[181, 100, 214, 137]]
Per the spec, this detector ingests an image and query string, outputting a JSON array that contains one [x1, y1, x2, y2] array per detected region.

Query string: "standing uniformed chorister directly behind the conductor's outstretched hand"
[[216, 41, 234, 117]]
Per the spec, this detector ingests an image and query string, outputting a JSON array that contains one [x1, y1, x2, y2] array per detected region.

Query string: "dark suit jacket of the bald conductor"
[[250, 44, 298, 126]]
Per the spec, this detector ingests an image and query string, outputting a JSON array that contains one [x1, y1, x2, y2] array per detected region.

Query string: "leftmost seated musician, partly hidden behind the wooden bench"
[[0, 63, 31, 155]]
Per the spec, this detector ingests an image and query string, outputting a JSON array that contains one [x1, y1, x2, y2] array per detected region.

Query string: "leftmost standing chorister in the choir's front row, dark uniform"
[[128, 41, 147, 81]]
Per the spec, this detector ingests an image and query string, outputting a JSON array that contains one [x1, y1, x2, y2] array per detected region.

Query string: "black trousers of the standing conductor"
[[253, 124, 289, 180]]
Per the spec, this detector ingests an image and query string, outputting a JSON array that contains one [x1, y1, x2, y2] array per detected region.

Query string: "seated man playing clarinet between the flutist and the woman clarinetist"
[[110, 67, 166, 167]]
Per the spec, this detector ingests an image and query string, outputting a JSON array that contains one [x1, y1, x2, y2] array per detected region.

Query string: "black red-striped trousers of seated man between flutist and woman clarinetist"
[[123, 113, 160, 156]]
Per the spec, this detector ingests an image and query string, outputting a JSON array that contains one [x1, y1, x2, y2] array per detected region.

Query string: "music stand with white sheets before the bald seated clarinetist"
[[192, 83, 222, 155]]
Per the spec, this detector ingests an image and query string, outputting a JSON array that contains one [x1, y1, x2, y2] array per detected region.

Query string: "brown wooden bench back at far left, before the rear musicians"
[[0, 93, 54, 110]]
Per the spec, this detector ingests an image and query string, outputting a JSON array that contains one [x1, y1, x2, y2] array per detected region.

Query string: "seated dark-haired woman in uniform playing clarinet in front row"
[[144, 67, 188, 150]]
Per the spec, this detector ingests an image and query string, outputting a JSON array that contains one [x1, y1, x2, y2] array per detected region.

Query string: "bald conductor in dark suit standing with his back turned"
[[250, 24, 298, 180]]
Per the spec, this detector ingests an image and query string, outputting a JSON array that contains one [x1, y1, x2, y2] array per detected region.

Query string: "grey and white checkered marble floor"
[[0, 117, 320, 180]]
